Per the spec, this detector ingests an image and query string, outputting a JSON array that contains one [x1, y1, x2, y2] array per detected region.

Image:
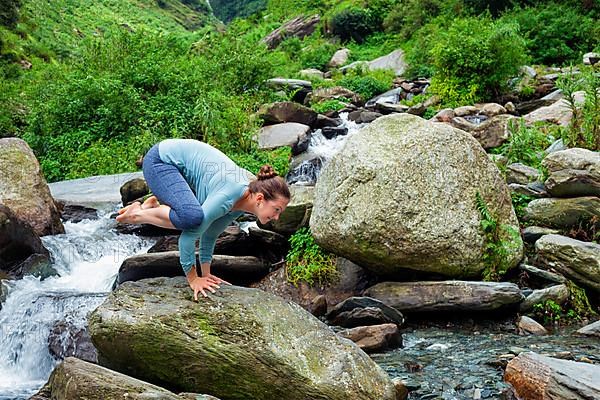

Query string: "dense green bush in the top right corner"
[[502, 2, 600, 65]]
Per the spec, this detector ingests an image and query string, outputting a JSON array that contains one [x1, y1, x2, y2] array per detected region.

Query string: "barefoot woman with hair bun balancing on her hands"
[[117, 139, 290, 300]]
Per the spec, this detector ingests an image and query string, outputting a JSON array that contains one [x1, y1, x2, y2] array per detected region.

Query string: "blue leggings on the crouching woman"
[[142, 144, 204, 230]]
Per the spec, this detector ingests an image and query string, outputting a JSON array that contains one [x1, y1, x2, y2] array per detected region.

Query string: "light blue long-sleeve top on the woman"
[[158, 139, 254, 275]]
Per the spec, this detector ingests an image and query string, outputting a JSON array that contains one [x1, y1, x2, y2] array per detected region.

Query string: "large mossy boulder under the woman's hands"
[[89, 278, 396, 400]]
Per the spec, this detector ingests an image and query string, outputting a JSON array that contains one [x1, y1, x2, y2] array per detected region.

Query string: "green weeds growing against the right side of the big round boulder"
[[475, 192, 522, 281]]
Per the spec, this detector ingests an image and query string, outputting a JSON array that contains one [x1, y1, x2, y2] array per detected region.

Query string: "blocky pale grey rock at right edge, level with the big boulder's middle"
[[542, 148, 600, 197]]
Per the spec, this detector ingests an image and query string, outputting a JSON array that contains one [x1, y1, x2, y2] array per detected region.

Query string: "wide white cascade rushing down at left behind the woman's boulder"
[[0, 210, 152, 400]]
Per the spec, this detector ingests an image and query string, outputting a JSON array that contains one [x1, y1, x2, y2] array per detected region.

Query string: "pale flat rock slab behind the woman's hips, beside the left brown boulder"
[[48, 172, 144, 207]]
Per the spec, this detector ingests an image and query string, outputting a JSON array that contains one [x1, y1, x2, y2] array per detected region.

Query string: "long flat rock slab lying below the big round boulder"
[[364, 281, 523, 313]]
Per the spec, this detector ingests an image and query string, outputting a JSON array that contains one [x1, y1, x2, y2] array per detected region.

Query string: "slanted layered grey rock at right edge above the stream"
[[535, 235, 600, 292]]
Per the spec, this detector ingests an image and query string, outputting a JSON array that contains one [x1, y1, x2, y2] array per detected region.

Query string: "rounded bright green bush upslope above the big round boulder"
[[431, 17, 526, 103]]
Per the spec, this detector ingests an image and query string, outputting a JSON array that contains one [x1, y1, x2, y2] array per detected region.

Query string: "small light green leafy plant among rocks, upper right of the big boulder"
[[494, 120, 554, 169]]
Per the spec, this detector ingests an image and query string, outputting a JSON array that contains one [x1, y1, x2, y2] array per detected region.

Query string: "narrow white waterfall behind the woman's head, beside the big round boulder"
[[286, 113, 363, 185]]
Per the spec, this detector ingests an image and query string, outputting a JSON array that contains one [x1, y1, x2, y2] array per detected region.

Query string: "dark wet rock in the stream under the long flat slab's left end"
[[327, 297, 404, 328]]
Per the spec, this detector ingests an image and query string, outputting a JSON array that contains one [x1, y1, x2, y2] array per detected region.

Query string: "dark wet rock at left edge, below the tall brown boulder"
[[0, 204, 51, 279]]
